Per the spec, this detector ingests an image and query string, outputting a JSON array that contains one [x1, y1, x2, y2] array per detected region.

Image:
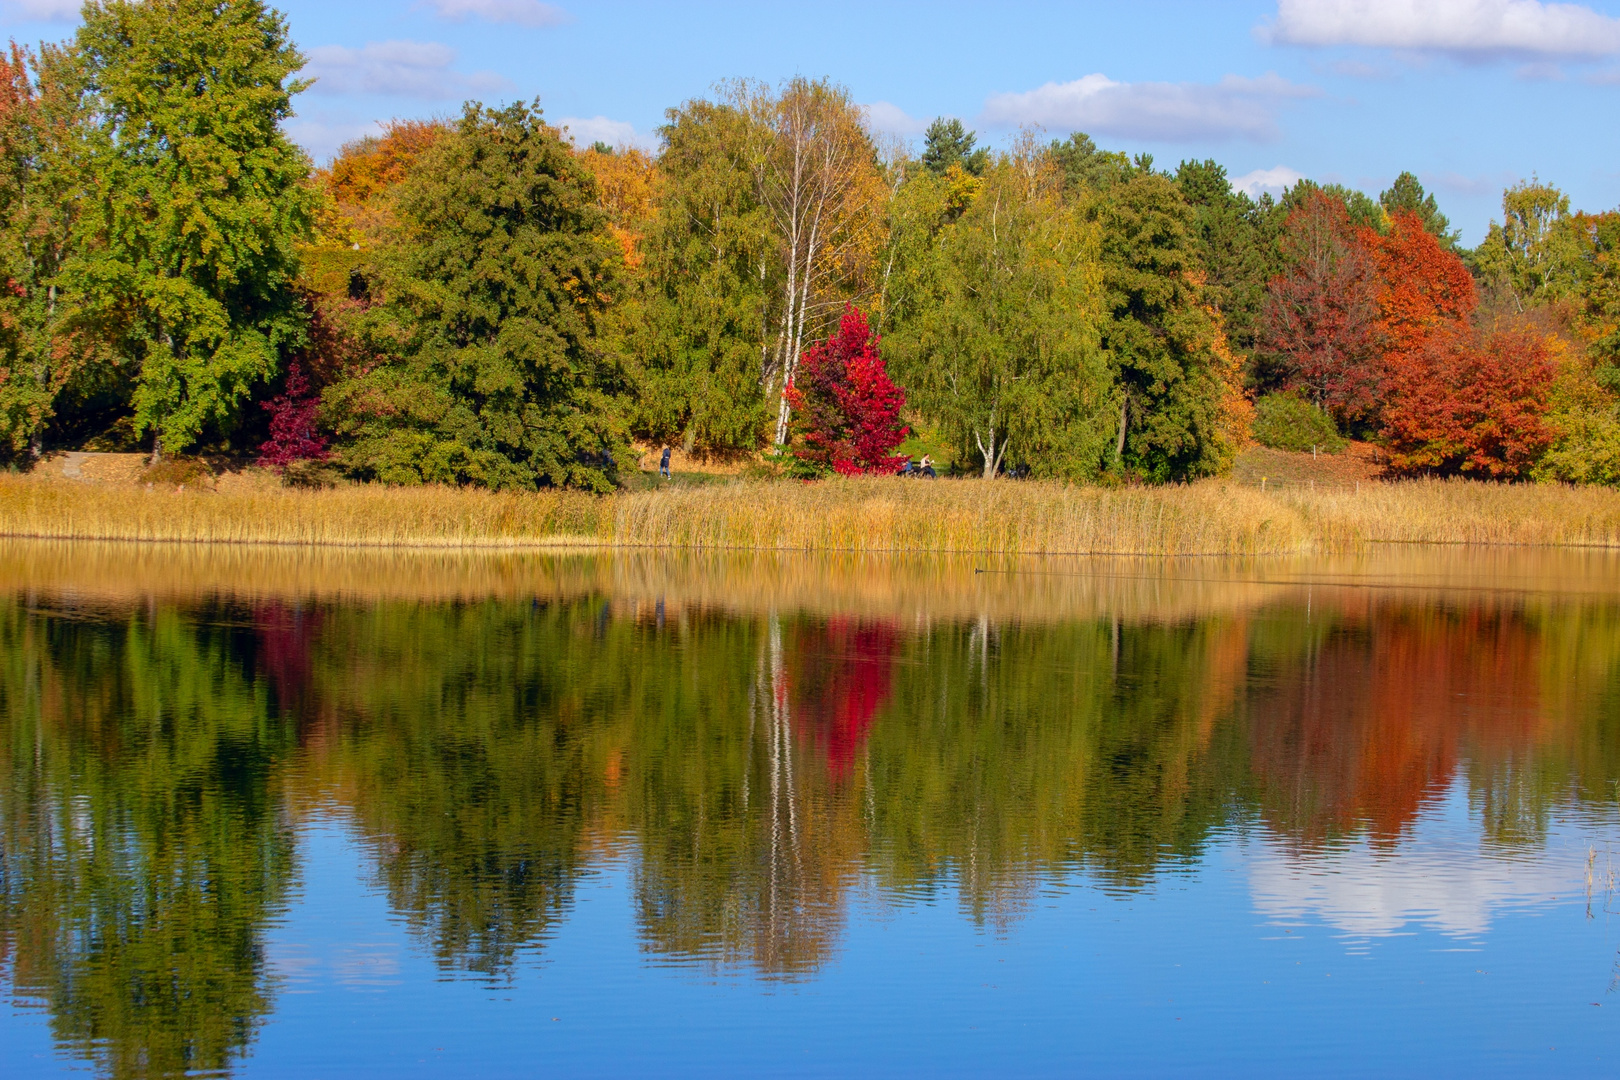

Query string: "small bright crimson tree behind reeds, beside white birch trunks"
[[787, 304, 909, 476]]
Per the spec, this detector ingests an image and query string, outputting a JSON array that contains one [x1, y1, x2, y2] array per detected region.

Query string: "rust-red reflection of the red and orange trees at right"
[[1249, 607, 1541, 840]]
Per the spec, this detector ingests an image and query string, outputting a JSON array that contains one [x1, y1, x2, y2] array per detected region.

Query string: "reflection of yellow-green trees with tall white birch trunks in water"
[[625, 615, 865, 975]]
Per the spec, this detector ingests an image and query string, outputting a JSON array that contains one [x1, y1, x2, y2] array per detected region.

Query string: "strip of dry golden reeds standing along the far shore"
[[0, 476, 1620, 555]]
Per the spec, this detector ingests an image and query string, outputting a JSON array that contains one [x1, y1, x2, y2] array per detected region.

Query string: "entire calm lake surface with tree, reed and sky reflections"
[[0, 542, 1620, 1077]]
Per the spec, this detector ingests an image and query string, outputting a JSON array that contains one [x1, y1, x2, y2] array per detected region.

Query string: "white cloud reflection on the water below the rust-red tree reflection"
[[1247, 784, 1602, 938]]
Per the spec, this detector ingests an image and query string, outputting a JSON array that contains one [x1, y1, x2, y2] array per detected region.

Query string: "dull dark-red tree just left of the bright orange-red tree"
[[1260, 191, 1382, 419]]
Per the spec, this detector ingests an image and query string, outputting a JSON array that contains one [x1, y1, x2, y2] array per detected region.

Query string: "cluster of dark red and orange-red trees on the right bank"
[[1264, 204, 1557, 479]]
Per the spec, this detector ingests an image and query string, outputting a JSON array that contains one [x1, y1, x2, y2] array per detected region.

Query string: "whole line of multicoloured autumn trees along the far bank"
[[0, 0, 1620, 491]]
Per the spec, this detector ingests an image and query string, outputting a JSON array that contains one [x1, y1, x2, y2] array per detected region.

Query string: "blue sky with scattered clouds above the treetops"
[[0, 0, 1620, 243]]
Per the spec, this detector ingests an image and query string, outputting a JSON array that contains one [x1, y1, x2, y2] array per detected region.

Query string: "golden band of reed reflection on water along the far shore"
[[9, 539, 1620, 627]]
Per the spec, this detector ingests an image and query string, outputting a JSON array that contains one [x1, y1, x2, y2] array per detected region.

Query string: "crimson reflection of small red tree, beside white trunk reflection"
[[787, 619, 899, 777]]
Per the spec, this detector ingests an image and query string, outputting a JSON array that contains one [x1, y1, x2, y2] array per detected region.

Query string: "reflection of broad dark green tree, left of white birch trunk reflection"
[[304, 602, 618, 975]]
